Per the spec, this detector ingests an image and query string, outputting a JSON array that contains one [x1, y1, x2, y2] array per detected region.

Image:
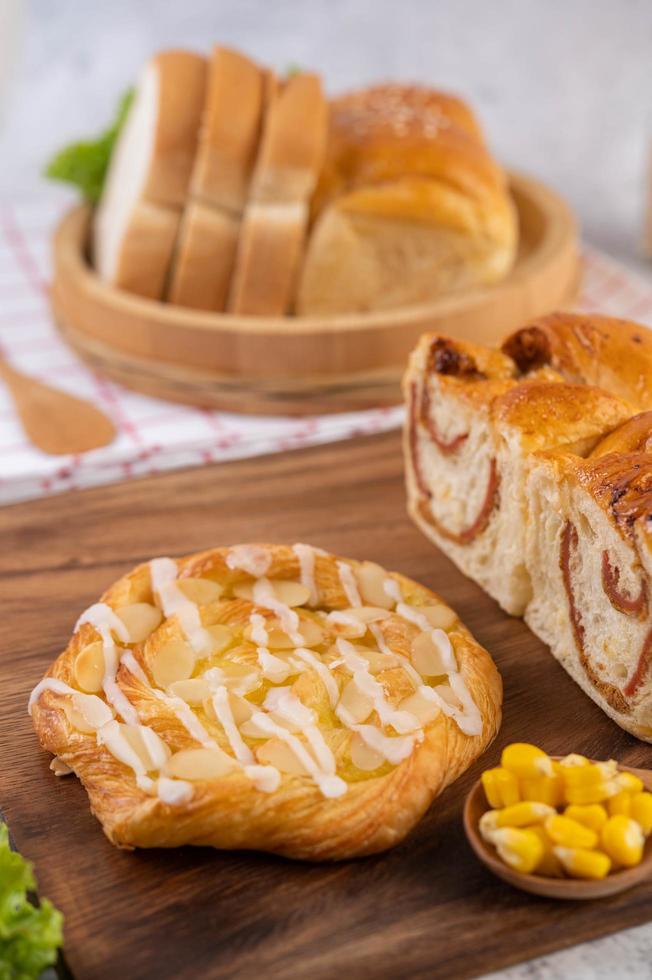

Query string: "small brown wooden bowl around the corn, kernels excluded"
[[464, 766, 652, 901]]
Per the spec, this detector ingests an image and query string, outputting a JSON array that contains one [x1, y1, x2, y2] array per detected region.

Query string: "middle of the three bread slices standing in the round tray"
[[167, 47, 265, 310]]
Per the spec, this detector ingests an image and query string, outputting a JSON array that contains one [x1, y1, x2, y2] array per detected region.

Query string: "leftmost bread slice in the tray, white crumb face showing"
[[93, 51, 206, 299]]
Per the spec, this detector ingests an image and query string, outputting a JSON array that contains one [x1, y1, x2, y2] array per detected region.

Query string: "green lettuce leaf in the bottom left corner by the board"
[[0, 822, 63, 980]]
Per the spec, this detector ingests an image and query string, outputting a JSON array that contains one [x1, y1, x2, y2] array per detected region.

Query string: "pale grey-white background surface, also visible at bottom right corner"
[[0, 0, 652, 980]]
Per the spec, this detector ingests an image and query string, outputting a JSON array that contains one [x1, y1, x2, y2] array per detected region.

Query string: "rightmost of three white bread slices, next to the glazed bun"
[[228, 72, 328, 316]]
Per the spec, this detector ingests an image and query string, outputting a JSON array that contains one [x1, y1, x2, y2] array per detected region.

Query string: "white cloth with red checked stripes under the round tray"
[[0, 197, 652, 503]]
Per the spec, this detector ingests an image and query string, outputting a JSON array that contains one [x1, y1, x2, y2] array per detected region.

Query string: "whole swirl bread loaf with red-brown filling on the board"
[[405, 313, 652, 741]]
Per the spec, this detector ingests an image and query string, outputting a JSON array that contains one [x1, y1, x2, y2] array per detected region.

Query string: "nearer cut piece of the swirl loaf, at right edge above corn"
[[525, 442, 652, 741]]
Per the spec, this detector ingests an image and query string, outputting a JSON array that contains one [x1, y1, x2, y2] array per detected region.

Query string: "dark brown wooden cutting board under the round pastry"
[[0, 433, 652, 980]]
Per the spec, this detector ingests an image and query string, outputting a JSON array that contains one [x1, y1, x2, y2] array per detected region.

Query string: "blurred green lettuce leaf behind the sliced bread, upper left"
[[44, 89, 134, 205]]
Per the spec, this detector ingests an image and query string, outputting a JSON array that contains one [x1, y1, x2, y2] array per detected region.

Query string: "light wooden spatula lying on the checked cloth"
[[0, 359, 115, 456]]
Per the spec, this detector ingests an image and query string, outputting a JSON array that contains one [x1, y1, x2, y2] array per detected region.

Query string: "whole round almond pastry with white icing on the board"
[[30, 545, 502, 860]]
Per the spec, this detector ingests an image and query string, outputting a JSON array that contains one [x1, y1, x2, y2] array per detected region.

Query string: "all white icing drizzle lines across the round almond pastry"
[[34, 544, 482, 805]]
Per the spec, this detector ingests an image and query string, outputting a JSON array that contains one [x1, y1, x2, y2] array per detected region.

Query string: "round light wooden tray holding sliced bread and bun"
[[52, 174, 579, 415]]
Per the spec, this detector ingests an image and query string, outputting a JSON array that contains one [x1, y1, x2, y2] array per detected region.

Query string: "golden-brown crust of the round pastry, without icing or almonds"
[[33, 545, 501, 860]]
